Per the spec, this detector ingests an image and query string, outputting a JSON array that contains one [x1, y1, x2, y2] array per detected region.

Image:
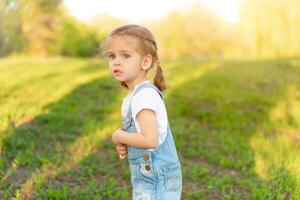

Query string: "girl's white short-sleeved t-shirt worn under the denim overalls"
[[122, 80, 168, 150]]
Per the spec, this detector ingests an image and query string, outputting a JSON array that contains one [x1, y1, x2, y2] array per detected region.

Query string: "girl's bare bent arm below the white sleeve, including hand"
[[112, 109, 158, 149]]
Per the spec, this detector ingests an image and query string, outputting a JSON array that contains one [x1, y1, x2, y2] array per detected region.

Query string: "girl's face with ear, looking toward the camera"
[[107, 35, 151, 86]]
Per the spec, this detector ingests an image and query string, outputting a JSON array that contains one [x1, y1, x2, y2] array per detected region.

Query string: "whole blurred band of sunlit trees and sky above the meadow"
[[0, 0, 300, 59]]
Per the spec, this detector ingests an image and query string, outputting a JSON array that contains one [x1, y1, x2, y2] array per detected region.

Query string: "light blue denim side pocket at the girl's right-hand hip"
[[162, 162, 182, 191]]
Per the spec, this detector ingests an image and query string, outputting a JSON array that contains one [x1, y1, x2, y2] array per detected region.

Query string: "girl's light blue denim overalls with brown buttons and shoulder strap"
[[122, 82, 182, 200]]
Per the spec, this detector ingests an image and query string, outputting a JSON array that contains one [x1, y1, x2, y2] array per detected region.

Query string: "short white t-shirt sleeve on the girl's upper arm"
[[131, 88, 160, 118]]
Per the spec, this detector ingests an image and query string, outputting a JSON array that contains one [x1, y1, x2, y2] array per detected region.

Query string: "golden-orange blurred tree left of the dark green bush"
[[19, 0, 65, 55]]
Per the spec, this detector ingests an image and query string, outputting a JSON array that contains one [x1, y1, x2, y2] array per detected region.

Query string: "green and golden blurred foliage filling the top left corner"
[[0, 0, 63, 55]]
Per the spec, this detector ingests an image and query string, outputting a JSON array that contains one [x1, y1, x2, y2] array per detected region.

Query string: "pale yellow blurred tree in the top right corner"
[[240, 0, 300, 58]]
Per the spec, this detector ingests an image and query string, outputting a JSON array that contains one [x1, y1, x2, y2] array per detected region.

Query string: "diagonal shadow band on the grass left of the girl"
[[0, 71, 125, 198]]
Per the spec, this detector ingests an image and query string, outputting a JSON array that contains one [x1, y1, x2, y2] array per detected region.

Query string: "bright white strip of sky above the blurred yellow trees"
[[64, 0, 241, 23]]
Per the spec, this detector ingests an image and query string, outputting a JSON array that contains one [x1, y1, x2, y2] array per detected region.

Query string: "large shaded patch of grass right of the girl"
[[167, 58, 300, 199]]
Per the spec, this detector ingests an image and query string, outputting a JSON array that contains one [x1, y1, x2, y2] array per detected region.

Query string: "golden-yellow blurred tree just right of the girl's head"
[[146, 3, 240, 59]]
